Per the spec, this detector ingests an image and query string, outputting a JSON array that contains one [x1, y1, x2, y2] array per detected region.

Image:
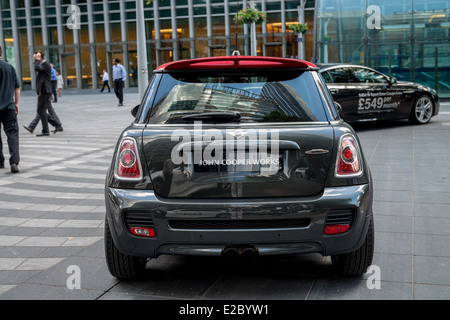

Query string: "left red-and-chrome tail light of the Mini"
[[115, 138, 142, 180]]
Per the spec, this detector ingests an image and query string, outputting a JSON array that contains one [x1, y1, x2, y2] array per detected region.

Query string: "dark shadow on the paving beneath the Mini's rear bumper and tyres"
[[110, 254, 370, 300]]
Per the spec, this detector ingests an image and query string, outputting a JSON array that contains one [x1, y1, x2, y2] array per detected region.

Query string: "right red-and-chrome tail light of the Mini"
[[336, 134, 362, 177]]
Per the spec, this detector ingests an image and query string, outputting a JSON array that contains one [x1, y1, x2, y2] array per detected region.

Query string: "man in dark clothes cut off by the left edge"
[[0, 47, 20, 173]]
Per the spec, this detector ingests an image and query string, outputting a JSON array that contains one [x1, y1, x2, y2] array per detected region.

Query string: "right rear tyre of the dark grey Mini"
[[331, 217, 375, 276]]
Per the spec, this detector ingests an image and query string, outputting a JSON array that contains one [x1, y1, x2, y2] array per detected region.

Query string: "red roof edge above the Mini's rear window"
[[156, 56, 317, 70]]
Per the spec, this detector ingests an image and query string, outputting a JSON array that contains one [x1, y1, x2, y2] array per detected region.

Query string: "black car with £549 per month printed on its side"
[[318, 64, 439, 124]]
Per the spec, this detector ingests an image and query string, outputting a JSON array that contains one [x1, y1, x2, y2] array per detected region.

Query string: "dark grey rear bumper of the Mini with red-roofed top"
[[106, 184, 372, 258]]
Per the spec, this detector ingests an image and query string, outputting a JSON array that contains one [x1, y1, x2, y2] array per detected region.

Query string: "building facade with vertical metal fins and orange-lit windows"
[[0, 0, 315, 89]]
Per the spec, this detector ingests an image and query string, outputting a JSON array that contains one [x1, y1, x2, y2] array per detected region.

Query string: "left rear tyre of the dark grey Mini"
[[104, 219, 147, 280]]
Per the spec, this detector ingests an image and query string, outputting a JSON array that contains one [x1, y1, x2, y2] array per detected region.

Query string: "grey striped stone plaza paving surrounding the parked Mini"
[[0, 89, 450, 300]]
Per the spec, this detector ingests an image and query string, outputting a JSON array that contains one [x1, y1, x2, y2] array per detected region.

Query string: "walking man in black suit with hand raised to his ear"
[[24, 51, 63, 137]]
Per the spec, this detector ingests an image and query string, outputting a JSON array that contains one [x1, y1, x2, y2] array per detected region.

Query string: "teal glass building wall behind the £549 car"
[[315, 0, 450, 98]]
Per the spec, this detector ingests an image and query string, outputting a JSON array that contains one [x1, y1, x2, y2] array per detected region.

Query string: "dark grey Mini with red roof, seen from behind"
[[105, 56, 374, 279]]
